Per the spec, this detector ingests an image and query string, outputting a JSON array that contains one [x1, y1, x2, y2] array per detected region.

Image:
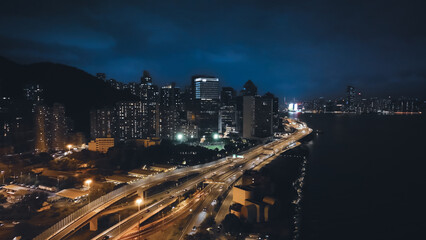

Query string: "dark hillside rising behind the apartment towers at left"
[[0, 57, 135, 134]]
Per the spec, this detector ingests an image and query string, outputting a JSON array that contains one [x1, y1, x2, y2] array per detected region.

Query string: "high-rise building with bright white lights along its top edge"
[[192, 76, 220, 136]]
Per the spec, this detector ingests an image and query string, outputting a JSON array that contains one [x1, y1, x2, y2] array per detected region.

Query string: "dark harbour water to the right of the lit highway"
[[294, 114, 426, 240]]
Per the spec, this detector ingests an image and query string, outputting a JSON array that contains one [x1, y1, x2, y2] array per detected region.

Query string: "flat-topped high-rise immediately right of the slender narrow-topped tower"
[[159, 83, 182, 139]]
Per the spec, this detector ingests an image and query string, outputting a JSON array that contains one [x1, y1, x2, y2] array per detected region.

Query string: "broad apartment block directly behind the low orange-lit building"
[[90, 108, 115, 139]]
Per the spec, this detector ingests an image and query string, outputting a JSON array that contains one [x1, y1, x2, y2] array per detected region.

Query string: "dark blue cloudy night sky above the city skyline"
[[0, 0, 426, 99]]
